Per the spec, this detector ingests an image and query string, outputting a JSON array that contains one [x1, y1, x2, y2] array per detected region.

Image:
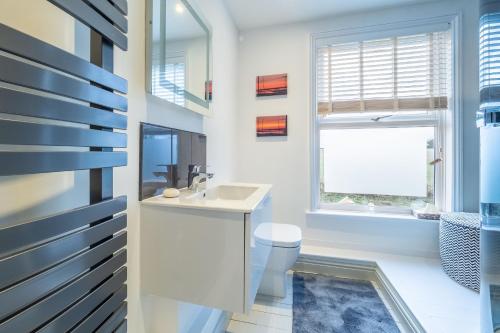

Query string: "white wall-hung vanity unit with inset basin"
[[141, 184, 272, 313]]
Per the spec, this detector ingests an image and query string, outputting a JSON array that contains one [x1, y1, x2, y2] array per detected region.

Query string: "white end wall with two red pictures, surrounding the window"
[[236, 0, 479, 255]]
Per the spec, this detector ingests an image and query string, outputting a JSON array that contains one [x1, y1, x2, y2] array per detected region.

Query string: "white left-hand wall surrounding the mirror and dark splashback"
[[115, 0, 238, 333]]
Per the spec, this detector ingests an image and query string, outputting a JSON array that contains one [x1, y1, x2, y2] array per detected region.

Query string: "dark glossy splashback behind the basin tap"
[[139, 123, 207, 200]]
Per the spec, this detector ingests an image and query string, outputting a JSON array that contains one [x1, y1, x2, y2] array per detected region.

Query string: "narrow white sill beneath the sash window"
[[306, 209, 439, 224]]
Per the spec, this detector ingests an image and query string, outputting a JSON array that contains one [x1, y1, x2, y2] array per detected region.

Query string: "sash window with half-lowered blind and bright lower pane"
[[315, 29, 451, 212]]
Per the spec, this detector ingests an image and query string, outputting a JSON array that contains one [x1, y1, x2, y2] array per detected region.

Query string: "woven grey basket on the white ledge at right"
[[439, 213, 480, 292]]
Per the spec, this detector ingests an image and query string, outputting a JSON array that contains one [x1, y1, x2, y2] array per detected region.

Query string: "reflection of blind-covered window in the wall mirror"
[[152, 53, 186, 106]]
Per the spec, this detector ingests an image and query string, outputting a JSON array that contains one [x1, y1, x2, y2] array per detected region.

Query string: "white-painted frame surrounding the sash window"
[[310, 14, 463, 214]]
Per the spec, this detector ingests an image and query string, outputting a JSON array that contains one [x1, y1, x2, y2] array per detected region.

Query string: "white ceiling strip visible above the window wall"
[[225, 0, 438, 30]]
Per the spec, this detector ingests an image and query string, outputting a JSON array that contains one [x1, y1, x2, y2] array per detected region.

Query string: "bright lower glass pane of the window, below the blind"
[[320, 127, 435, 207]]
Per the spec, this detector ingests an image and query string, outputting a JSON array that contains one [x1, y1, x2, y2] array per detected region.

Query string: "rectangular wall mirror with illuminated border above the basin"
[[146, 0, 212, 114]]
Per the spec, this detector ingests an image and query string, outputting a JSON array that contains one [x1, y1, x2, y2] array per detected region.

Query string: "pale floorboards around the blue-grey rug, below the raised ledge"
[[226, 272, 399, 333]]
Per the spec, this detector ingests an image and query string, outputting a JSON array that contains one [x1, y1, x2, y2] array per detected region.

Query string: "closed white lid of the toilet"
[[254, 223, 302, 247]]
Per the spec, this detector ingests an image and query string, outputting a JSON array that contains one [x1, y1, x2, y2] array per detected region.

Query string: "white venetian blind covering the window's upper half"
[[316, 30, 451, 115]]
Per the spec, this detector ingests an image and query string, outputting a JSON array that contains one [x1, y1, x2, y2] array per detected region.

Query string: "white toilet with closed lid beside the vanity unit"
[[254, 223, 302, 297]]
